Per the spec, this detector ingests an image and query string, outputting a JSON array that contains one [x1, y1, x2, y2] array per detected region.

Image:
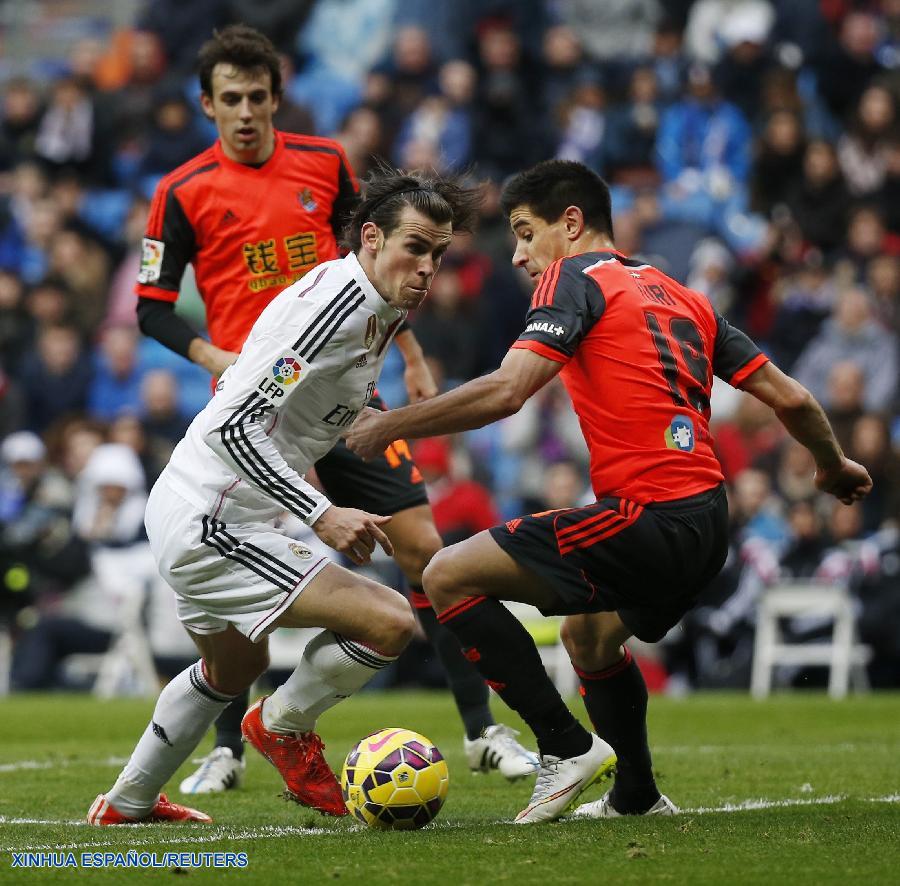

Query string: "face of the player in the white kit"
[[363, 206, 453, 310]]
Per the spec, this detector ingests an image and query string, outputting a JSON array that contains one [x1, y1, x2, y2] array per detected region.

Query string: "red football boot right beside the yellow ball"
[[241, 697, 347, 815]]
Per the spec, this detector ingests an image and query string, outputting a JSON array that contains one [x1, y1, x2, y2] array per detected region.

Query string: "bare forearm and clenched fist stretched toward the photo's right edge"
[[741, 363, 872, 505]]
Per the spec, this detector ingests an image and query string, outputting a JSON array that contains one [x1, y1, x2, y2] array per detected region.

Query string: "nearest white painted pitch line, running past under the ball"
[[0, 794, 900, 853]]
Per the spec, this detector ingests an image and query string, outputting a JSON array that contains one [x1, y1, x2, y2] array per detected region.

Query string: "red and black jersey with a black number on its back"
[[513, 252, 768, 504]]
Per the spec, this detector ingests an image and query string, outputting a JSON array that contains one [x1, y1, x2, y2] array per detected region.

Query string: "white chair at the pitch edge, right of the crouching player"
[[750, 581, 872, 698]]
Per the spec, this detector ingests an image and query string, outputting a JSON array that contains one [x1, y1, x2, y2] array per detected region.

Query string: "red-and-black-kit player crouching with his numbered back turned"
[[347, 160, 872, 824]]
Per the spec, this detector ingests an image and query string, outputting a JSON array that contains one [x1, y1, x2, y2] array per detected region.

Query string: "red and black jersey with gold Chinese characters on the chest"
[[136, 132, 359, 351]]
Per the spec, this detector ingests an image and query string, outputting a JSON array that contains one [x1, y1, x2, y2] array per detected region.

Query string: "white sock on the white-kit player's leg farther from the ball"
[[106, 661, 233, 818]]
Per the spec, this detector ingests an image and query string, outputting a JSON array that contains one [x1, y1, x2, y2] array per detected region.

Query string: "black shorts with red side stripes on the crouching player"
[[490, 486, 728, 643]]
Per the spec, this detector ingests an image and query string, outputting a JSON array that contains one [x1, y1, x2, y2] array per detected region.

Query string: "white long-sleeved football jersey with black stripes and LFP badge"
[[158, 253, 406, 525]]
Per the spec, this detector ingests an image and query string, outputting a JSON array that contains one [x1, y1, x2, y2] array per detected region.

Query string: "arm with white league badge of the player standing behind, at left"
[[135, 179, 237, 376]]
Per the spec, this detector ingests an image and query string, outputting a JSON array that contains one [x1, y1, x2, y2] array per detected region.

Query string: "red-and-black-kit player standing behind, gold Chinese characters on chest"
[[137, 25, 538, 793]]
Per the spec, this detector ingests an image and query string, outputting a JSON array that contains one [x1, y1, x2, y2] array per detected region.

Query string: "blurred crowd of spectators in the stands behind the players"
[[0, 0, 900, 688]]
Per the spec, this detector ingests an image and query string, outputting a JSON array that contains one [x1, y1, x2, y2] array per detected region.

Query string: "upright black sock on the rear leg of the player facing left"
[[575, 648, 659, 815]]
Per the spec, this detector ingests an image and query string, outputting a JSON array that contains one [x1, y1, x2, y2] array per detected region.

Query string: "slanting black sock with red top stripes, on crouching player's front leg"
[[438, 597, 591, 757]]
